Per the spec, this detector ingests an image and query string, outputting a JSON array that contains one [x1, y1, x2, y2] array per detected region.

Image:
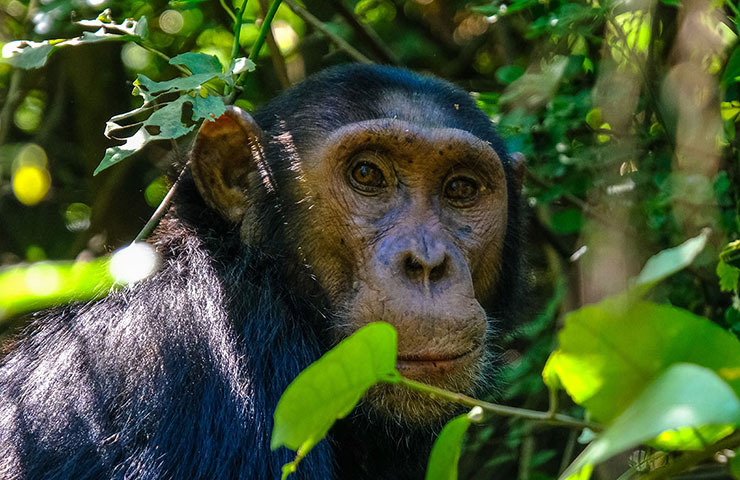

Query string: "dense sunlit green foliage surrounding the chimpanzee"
[[0, 0, 740, 479]]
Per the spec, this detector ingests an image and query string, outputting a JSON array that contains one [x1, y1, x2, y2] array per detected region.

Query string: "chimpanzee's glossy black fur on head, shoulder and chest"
[[0, 66, 519, 480]]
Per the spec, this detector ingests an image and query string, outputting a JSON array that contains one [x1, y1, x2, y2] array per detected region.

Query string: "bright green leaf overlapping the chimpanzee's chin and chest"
[[270, 322, 400, 457]]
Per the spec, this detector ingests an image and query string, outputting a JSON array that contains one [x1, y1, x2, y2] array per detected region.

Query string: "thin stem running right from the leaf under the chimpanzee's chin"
[[399, 377, 604, 431]]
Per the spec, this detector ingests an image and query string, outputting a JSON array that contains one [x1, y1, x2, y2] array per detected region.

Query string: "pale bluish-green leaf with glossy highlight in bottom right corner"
[[561, 363, 740, 478]]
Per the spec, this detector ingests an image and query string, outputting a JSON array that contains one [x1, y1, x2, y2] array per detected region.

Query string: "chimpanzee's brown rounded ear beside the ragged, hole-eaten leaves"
[[190, 106, 263, 222]]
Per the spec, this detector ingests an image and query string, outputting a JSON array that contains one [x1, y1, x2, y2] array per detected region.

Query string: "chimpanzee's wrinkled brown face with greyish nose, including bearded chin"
[[298, 120, 507, 422]]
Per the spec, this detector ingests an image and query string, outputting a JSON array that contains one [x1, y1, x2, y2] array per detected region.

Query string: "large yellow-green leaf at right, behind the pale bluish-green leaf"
[[548, 297, 740, 422]]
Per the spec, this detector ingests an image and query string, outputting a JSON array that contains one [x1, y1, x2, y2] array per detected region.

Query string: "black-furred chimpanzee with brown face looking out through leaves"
[[0, 65, 522, 480]]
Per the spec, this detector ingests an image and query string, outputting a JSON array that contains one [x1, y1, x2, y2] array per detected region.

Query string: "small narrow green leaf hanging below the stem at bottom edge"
[[425, 407, 483, 480]]
